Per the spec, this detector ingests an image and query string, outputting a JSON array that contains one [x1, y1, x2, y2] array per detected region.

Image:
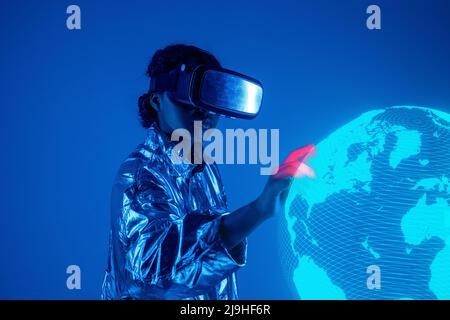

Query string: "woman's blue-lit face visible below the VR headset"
[[157, 92, 219, 136]]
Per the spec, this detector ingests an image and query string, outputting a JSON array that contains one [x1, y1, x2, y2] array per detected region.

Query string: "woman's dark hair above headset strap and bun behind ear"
[[138, 44, 221, 128]]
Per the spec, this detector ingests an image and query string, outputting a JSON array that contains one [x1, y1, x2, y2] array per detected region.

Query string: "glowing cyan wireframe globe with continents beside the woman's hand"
[[282, 106, 450, 299]]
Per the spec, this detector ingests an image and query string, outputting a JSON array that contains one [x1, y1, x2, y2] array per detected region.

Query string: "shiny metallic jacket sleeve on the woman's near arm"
[[120, 167, 247, 299]]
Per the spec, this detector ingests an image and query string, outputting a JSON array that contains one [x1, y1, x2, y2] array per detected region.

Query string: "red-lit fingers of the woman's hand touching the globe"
[[274, 144, 316, 179]]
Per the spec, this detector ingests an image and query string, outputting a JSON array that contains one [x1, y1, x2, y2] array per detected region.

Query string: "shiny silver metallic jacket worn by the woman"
[[102, 125, 247, 299]]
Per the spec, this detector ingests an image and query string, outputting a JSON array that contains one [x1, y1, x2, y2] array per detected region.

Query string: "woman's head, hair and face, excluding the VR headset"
[[139, 44, 221, 134]]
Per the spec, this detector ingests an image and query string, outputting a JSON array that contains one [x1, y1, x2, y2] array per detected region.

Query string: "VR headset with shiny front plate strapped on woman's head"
[[149, 64, 263, 119]]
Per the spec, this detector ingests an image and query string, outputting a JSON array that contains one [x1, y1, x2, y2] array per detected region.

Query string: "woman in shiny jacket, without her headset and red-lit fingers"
[[102, 45, 291, 299]]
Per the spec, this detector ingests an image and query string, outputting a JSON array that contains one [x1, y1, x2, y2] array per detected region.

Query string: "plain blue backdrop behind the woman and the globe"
[[0, 0, 450, 299]]
